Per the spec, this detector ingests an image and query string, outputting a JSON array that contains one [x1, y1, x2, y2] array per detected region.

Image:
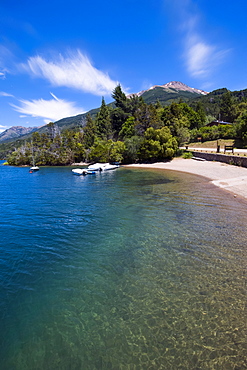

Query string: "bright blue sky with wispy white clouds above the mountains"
[[0, 0, 247, 132]]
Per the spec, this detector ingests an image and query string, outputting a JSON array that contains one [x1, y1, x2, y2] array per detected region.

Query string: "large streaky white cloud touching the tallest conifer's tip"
[[22, 50, 118, 96]]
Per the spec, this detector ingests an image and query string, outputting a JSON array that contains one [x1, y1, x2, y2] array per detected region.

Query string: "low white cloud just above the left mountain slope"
[[11, 93, 84, 123]]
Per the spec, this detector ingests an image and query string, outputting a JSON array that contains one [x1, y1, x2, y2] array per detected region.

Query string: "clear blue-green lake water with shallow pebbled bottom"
[[0, 165, 247, 370]]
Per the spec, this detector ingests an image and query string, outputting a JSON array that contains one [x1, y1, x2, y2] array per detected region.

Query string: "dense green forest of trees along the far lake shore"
[[7, 85, 247, 166]]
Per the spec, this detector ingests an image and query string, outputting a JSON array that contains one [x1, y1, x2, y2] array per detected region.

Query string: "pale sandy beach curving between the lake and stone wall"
[[125, 158, 247, 199]]
